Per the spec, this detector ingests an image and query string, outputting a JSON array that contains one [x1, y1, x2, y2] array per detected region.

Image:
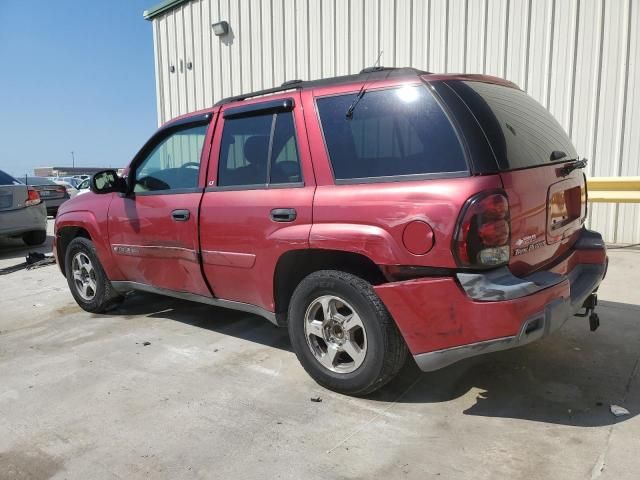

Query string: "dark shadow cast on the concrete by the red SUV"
[[111, 292, 640, 427]]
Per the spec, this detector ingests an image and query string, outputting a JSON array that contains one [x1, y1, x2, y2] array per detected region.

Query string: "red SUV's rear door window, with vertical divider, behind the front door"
[[218, 112, 302, 187]]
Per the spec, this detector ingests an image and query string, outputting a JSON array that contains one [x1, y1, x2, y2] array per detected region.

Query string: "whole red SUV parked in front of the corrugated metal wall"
[[54, 68, 607, 395]]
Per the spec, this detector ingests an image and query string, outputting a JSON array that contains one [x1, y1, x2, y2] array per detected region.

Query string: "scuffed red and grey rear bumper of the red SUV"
[[375, 230, 607, 371]]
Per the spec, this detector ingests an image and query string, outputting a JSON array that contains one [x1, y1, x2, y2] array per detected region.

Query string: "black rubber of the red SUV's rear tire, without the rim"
[[288, 270, 407, 396]]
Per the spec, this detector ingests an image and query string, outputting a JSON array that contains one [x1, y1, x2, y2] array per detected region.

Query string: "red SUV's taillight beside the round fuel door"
[[453, 191, 511, 268]]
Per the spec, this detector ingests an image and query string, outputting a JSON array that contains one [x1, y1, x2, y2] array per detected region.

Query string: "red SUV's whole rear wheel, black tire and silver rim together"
[[289, 270, 407, 395]]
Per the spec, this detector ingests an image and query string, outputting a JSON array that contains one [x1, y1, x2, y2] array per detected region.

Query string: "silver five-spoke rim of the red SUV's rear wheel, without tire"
[[304, 295, 367, 373]]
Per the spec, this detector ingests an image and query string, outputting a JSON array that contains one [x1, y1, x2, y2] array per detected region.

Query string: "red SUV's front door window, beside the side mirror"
[[133, 125, 208, 193]]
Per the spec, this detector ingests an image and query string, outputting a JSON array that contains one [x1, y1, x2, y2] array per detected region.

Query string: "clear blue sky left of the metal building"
[[0, 0, 159, 176]]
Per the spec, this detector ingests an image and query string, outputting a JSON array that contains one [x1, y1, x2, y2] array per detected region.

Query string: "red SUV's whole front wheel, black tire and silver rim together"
[[65, 237, 122, 313]]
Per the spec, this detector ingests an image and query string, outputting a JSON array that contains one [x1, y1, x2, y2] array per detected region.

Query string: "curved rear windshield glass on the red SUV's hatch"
[[450, 82, 578, 170]]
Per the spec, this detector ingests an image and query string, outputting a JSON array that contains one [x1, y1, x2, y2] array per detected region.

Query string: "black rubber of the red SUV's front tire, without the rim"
[[64, 237, 123, 313]]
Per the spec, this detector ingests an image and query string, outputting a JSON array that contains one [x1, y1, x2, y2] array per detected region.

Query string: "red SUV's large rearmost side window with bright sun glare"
[[317, 85, 468, 181]]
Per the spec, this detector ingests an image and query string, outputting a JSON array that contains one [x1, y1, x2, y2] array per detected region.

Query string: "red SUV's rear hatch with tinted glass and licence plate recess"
[[450, 81, 587, 275]]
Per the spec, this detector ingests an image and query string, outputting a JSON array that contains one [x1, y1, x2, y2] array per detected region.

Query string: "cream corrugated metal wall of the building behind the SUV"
[[153, 0, 640, 243]]
